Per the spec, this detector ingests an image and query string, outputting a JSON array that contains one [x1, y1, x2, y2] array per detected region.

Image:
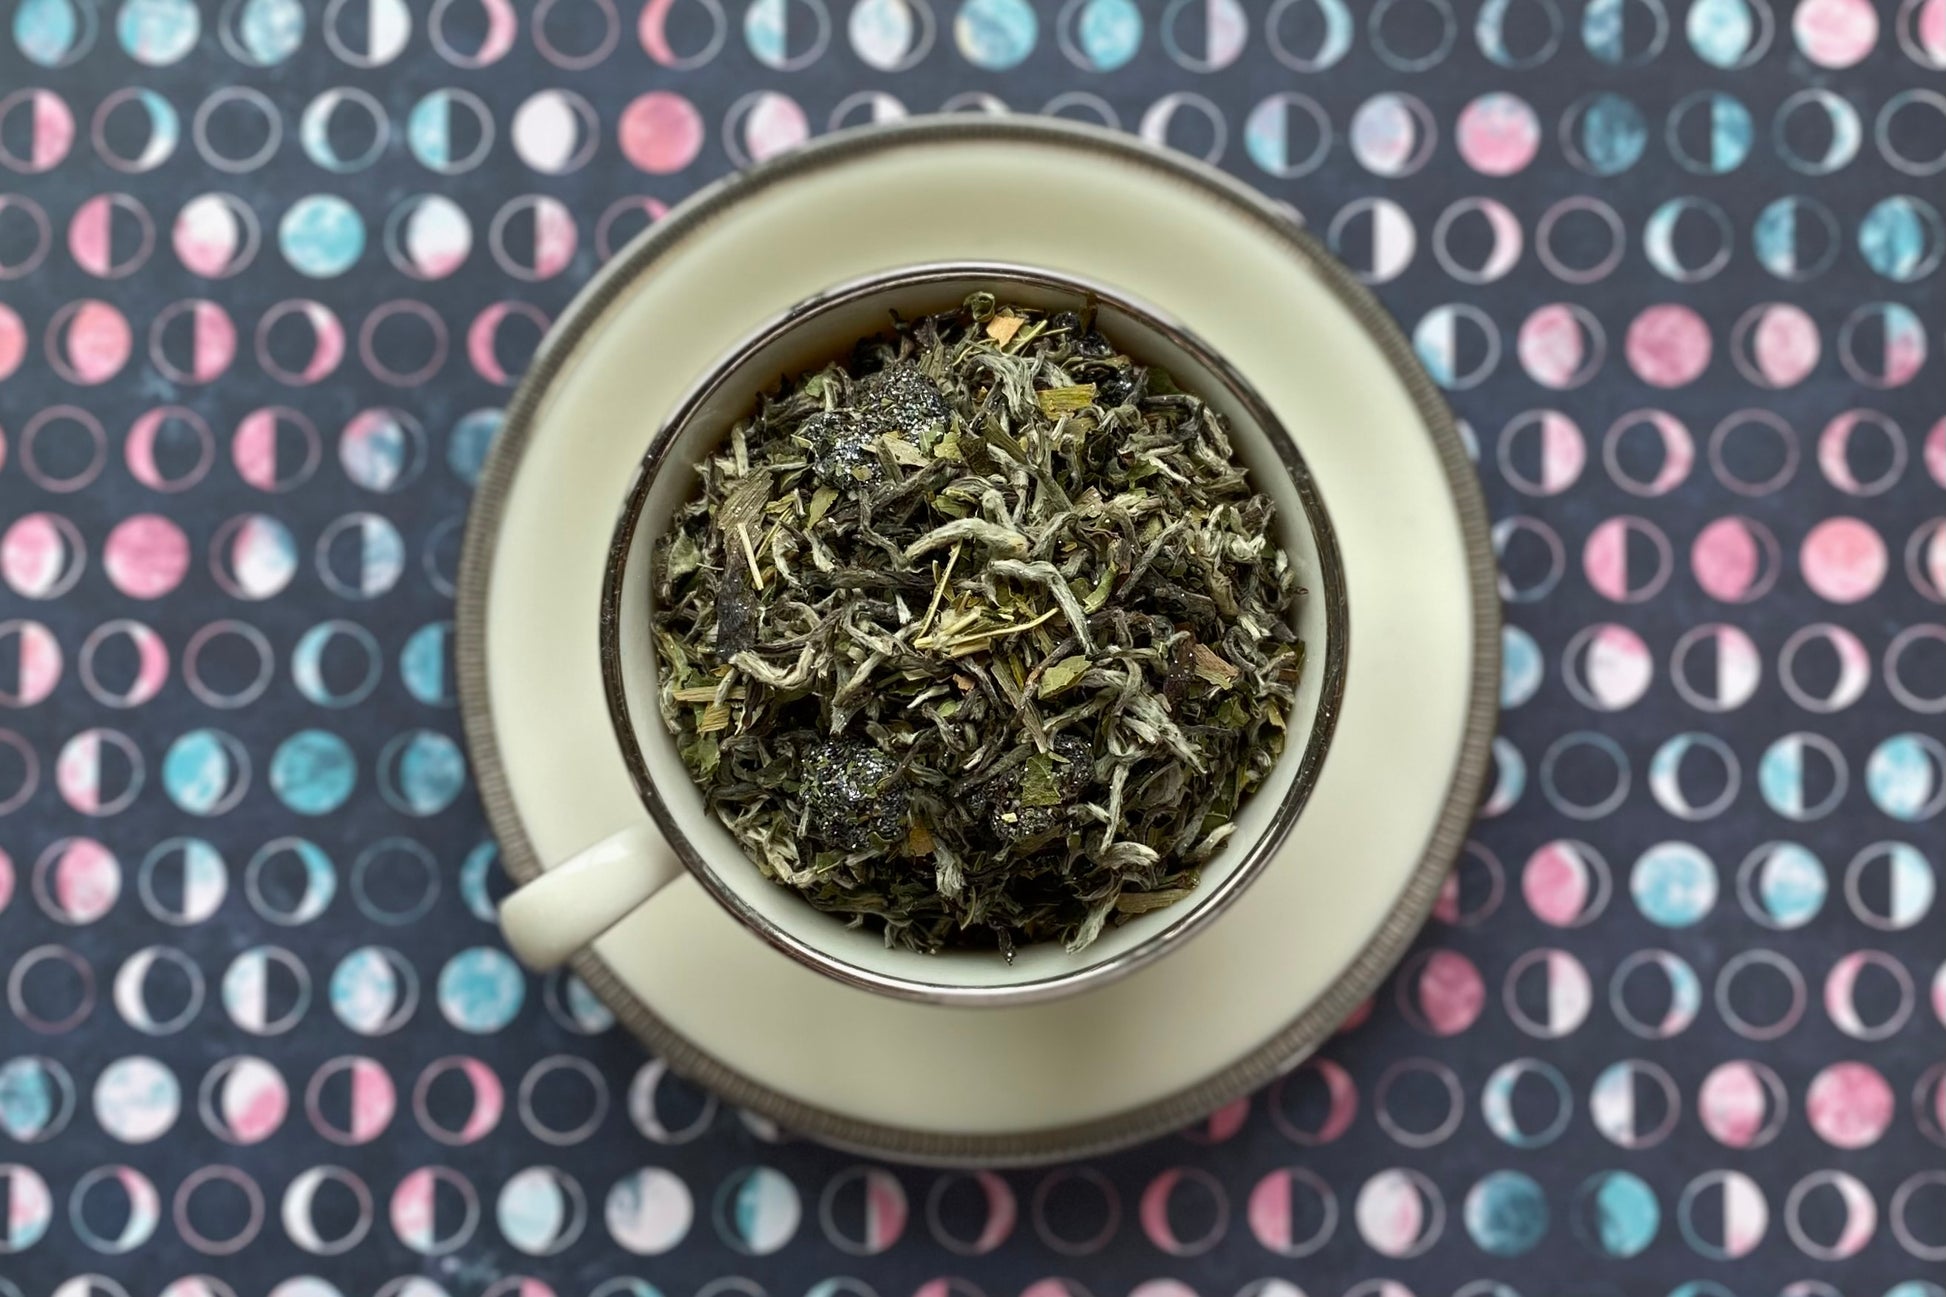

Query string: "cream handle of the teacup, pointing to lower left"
[[500, 820, 683, 972]]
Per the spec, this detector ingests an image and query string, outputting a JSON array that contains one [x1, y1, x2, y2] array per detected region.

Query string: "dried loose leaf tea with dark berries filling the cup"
[[654, 294, 1304, 954]]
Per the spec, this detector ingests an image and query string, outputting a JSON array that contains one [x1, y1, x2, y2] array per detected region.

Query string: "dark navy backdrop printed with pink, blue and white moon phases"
[[0, 0, 1946, 1297]]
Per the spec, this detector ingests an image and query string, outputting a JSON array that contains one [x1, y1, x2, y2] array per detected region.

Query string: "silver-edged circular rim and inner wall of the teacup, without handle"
[[601, 261, 1351, 1005]]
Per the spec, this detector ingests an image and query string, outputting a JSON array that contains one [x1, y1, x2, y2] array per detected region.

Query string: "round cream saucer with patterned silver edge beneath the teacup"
[[457, 117, 1498, 1165]]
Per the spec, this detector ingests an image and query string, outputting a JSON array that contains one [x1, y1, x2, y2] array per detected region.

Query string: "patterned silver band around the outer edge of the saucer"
[[455, 117, 1500, 1167]]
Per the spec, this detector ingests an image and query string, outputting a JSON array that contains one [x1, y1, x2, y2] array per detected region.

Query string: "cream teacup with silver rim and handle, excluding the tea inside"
[[500, 263, 1347, 1005]]
